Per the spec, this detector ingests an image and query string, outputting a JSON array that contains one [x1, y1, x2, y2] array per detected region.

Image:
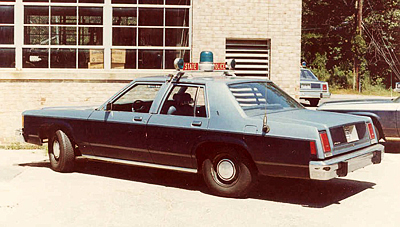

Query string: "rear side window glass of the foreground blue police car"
[[161, 85, 207, 117]]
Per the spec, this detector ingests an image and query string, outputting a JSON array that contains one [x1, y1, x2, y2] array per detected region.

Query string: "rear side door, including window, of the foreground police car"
[[147, 84, 209, 168]]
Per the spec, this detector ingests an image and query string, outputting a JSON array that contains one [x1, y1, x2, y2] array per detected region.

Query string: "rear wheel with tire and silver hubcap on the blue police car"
[[202, 149, 256, 197]]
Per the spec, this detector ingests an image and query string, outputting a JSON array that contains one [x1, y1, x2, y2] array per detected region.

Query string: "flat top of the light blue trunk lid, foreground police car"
[[268, 109, 368, 130]]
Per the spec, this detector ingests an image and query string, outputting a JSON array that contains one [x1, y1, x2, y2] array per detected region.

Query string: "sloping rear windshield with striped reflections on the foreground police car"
[[229, 82, 304, 116]]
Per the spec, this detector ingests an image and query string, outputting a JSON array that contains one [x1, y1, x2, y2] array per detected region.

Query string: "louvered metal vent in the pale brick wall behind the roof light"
[[225, 39, 270, 78]]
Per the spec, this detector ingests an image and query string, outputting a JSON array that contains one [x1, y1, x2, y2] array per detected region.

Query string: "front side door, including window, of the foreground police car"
[[88, 83, 161, 162]]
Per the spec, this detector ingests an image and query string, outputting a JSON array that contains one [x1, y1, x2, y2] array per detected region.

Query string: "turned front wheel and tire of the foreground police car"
[[48, 130, 75, 172]]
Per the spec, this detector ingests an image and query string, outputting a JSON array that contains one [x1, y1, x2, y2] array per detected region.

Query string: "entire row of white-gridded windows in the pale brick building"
[[0, 0, 192, 69]]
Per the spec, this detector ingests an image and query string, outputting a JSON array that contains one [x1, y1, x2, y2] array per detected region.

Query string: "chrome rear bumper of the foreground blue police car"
[[309, 144, 385, 180]]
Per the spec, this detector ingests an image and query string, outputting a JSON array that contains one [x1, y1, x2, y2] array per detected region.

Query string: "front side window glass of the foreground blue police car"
[[111, 84, 161, 113]]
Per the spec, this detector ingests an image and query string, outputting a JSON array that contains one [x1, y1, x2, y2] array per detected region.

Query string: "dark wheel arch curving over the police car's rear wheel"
[[196, 142, 258, 172]]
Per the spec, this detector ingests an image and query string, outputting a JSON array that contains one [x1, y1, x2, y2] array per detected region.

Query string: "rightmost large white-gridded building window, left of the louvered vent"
[[111, 0, 191, 69]]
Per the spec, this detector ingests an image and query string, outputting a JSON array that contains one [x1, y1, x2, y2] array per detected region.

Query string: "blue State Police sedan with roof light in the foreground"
[[22, 52, 384, 197]]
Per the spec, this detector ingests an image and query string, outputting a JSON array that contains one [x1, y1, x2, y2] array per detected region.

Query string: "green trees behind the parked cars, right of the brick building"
[[302, 0, 400, 91]]
